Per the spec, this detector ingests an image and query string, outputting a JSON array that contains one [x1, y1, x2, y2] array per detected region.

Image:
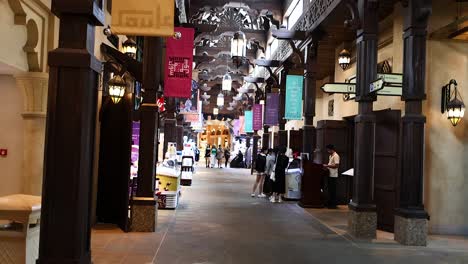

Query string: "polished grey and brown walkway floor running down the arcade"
[[92, 168, 468, 264]]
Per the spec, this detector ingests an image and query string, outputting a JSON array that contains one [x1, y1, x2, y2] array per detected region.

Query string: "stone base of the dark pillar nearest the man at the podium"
[[348, 210, 377, 239]]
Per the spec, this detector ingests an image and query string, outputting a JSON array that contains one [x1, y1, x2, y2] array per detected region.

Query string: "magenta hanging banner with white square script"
[[164, 27, 195, 98]]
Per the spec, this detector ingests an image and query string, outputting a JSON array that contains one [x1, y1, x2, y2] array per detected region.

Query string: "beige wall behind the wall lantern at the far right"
[[425, 1, 468, 235]]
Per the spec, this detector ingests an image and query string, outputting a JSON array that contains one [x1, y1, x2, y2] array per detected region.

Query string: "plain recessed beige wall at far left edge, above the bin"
[[0, 75, 24, 196]]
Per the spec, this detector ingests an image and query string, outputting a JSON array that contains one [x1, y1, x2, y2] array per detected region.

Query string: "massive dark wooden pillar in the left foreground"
[[37, 0, 104, 264]]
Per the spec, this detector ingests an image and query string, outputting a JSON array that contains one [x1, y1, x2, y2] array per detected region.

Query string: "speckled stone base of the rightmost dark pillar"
[[395, 215, 428, 246]]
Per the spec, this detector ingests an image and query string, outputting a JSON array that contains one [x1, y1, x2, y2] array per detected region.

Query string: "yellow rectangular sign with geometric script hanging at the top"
[[111, 0, 174, 37]]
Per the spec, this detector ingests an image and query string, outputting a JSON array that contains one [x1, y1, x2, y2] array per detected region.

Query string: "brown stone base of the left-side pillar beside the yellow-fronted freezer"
[[130, 197, 158, 232]]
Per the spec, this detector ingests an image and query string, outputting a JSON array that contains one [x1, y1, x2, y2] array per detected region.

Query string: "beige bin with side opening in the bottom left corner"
[[0, 194, 41, 264]]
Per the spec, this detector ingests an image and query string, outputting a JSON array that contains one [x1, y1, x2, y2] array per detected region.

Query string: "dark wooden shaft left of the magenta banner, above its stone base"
[[137, 37, 163, 197]]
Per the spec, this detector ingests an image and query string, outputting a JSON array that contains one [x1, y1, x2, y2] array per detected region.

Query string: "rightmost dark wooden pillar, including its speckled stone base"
[[395, 0, 432, 246]]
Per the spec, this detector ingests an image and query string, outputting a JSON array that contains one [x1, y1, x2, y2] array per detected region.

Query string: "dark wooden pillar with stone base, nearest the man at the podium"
[[348, 0, 379, 239]]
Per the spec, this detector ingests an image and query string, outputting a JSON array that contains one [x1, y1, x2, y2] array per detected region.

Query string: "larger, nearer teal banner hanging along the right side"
[[284, 75, 304, 120]]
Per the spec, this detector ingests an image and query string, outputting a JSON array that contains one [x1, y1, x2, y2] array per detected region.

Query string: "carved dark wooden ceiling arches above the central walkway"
[[187, 0, 283, 116]]
